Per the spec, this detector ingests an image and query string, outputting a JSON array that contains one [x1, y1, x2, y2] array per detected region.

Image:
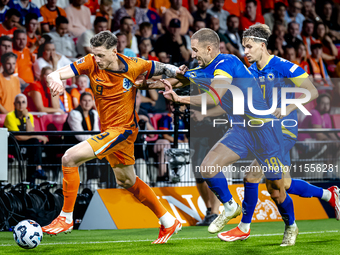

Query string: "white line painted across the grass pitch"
[[0, 230, 340, 247]]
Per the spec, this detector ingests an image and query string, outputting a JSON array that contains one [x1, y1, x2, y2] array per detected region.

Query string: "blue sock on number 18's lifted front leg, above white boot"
[[204, 172, 233, 204]]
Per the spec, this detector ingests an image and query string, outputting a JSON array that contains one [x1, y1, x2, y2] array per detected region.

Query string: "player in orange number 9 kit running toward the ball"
[[42, 31, 183, 243]]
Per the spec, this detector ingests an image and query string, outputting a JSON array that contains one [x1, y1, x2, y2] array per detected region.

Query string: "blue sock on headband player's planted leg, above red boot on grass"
[[241, 182, 259, 223]]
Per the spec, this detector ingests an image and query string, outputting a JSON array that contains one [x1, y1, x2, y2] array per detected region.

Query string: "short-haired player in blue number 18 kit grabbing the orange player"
[[158, 29, 297, 245]]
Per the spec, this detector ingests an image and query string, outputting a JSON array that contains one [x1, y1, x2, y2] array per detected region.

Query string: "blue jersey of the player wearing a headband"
[[249, 55, 308, 139]]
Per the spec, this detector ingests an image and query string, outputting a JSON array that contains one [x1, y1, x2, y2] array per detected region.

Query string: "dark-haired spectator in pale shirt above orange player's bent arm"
[[48, 16, 77, 58]]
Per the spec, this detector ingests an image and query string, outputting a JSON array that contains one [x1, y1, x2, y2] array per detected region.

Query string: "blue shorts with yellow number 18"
[[219, 122, 287, 180]]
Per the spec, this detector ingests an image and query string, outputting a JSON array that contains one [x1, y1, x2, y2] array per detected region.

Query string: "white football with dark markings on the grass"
[[13, 220, 43, 249]]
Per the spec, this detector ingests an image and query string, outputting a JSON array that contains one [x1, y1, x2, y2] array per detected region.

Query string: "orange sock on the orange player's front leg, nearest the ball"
[[62, 166, 80, 213]]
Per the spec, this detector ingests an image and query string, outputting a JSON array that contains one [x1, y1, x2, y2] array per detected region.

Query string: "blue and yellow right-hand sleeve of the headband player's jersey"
[[279, 60, 308, 87]]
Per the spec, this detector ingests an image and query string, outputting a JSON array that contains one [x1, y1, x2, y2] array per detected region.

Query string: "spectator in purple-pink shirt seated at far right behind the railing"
[[298, 94, 339, 141]]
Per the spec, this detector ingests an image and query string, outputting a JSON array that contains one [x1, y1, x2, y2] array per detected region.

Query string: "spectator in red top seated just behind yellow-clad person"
[[23, 66, 65, 114]]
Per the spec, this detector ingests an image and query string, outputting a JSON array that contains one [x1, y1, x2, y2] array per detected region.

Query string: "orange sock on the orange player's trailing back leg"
[[127, 176, 167, 218]]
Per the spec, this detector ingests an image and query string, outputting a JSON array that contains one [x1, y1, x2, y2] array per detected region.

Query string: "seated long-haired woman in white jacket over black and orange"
[[63, 92, 104, 184]]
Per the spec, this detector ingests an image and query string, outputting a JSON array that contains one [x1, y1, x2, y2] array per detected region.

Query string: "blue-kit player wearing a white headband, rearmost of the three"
[[208, 24, 340, 244]]
